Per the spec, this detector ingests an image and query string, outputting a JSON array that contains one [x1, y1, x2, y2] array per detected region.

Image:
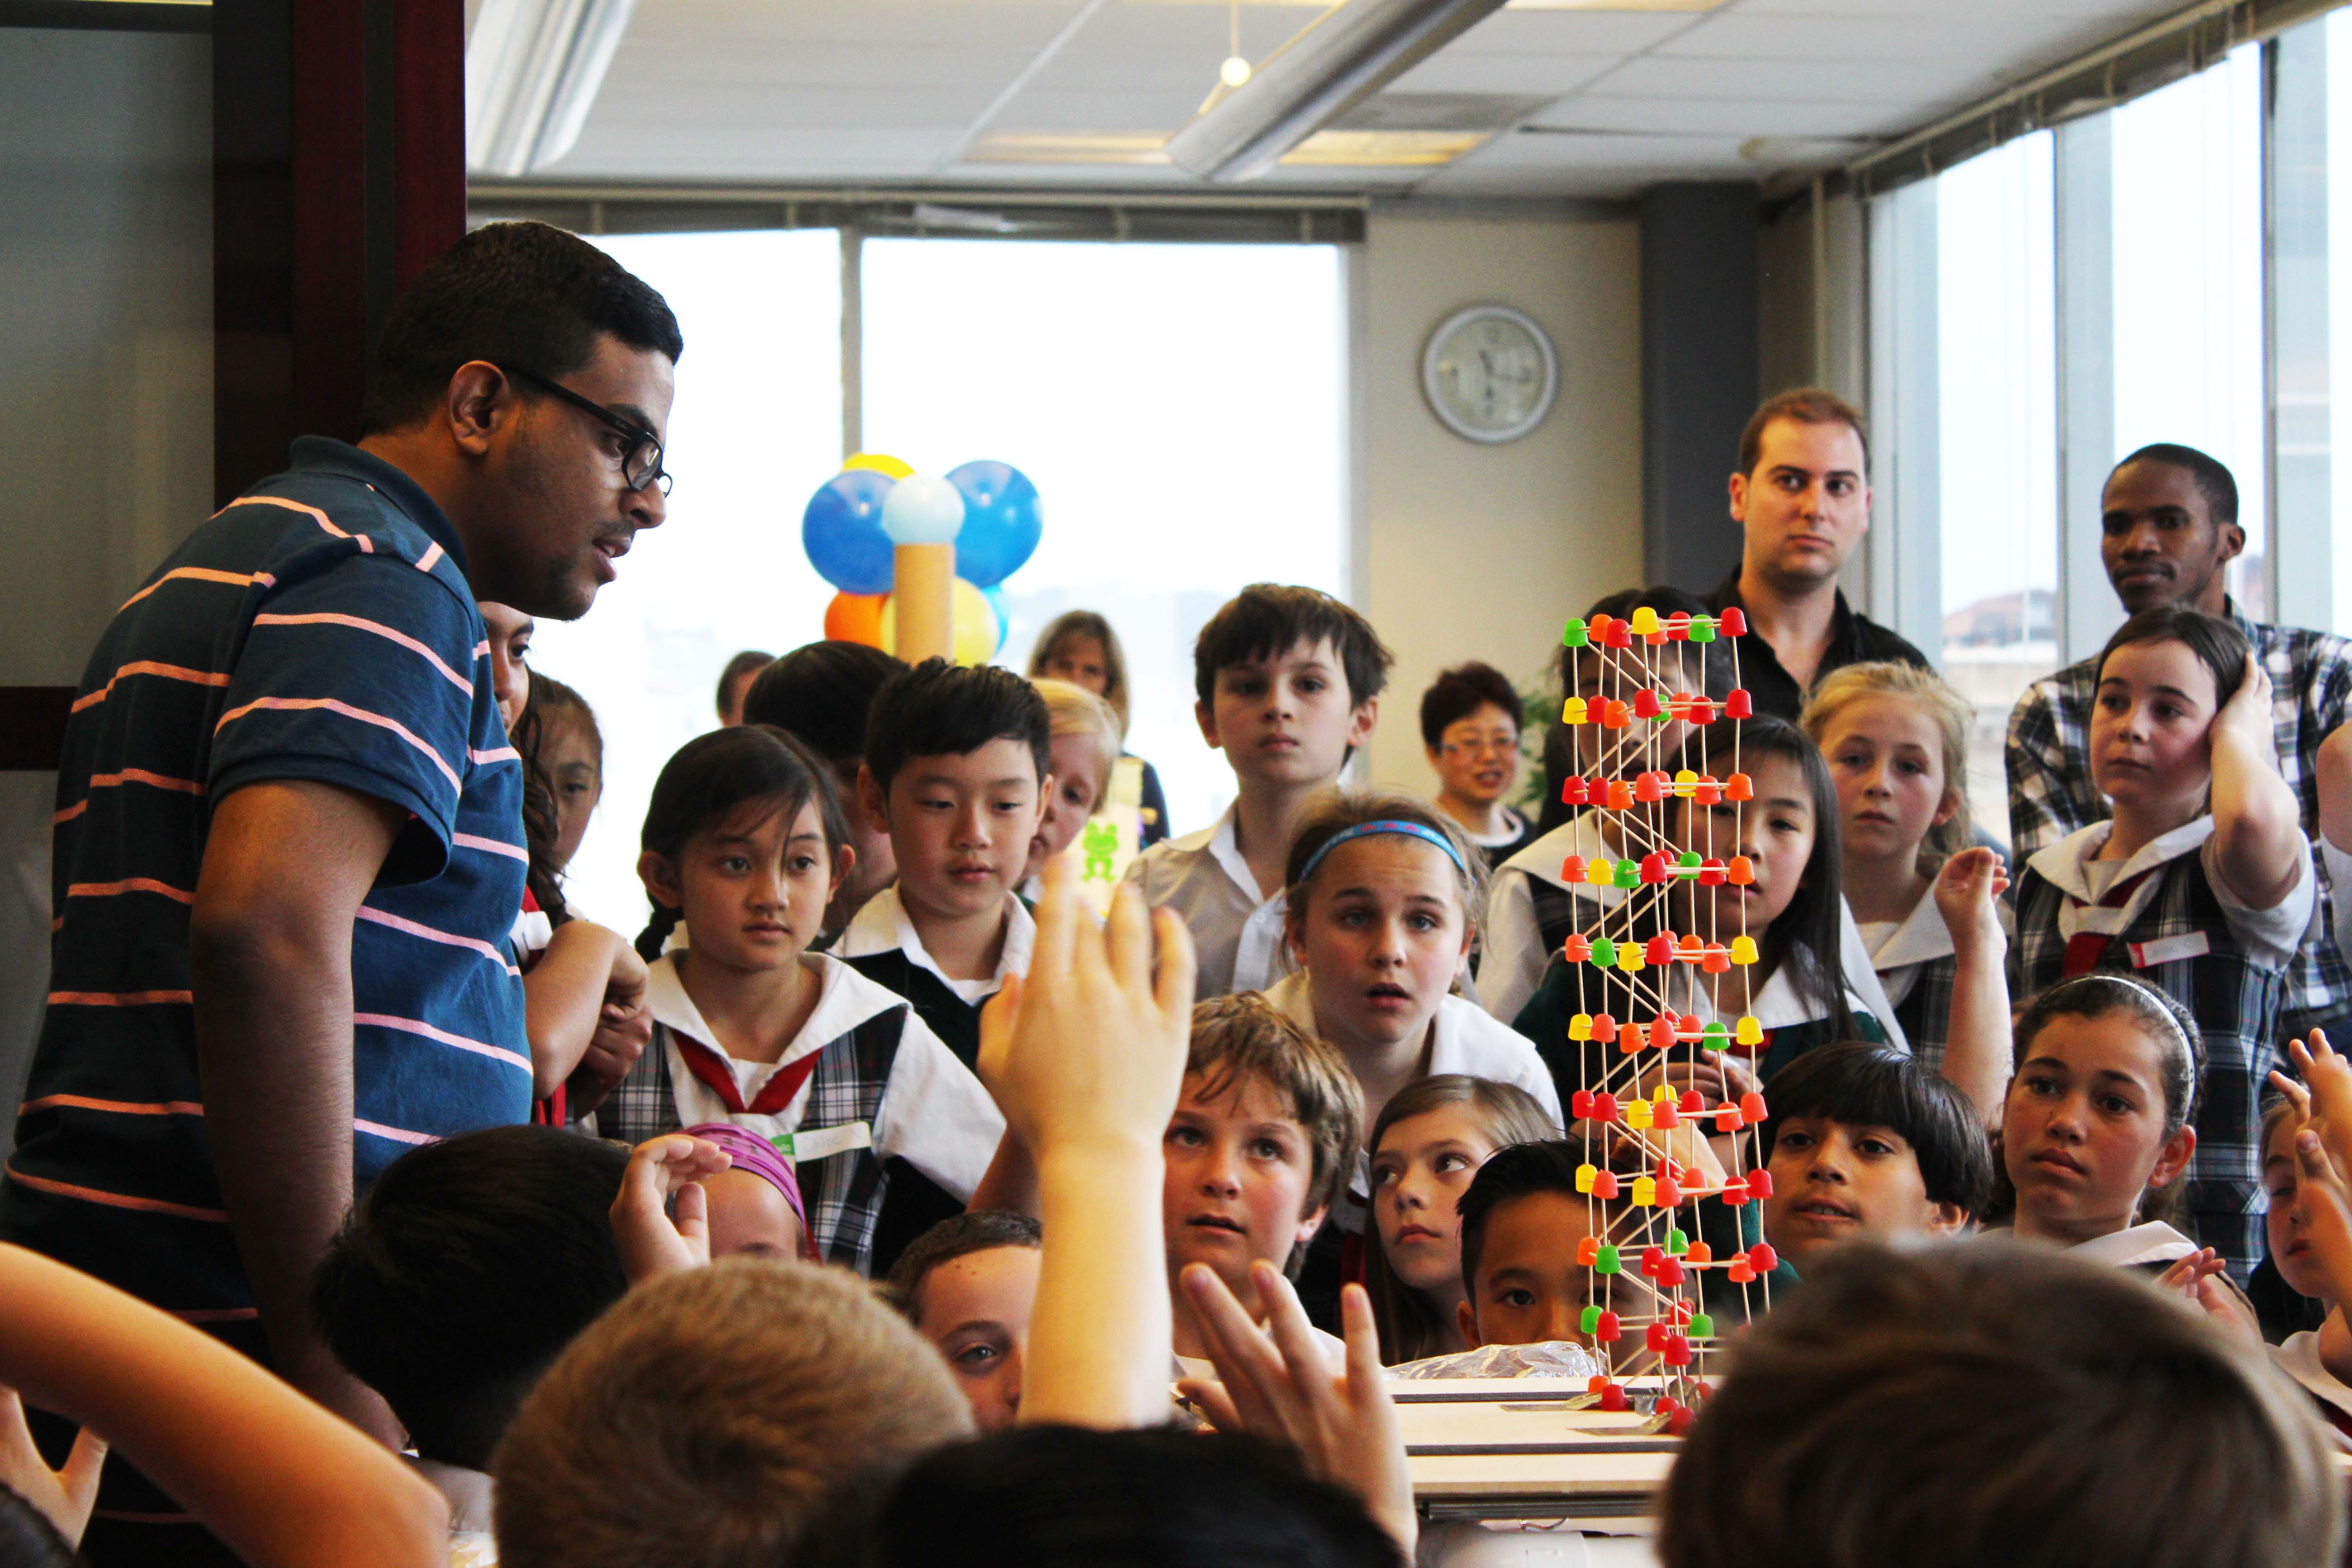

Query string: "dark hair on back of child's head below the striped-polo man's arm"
[[310, 1126, 628, 1469]]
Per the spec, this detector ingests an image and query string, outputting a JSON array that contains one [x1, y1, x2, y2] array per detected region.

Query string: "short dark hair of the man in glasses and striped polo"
[[360, 223, 687, 435]]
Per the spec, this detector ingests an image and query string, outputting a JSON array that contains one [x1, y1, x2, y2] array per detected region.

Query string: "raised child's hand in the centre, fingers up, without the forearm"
[[979, 858, 1192, 1161]]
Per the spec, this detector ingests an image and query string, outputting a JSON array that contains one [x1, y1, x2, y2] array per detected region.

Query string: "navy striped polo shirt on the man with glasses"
[[0, 437, 532, 1354]]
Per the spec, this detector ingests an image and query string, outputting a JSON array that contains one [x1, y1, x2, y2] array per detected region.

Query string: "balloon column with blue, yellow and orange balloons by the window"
[[800, 451, 1044, 665]]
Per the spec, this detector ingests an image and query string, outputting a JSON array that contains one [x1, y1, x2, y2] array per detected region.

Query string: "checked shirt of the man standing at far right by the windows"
[[2006, 599, 2352, 1034]]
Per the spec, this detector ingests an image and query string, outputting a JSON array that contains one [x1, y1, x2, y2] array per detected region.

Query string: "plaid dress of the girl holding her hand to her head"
[[2011, 851, 2288, 1286]]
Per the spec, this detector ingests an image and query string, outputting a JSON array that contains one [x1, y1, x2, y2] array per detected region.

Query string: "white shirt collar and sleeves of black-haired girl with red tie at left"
[[644, 950, 1004, 1201]]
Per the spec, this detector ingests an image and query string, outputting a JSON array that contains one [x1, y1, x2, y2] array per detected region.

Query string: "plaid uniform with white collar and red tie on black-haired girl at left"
[[595, 947, 1004, 1274]]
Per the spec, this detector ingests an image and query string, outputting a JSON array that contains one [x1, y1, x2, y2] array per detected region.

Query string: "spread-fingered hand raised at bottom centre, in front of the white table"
[[1178, 1260, 1418, 1561]]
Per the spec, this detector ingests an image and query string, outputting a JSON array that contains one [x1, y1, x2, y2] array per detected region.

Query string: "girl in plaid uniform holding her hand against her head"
[[2011, 604, 2317, 1281]]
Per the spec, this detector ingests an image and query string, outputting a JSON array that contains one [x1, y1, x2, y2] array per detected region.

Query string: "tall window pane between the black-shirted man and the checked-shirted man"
[[1936, 132, 2058, 842]]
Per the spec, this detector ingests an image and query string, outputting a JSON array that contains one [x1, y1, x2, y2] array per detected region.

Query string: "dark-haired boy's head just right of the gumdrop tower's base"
[[1764, 1041, 1992, 1267]]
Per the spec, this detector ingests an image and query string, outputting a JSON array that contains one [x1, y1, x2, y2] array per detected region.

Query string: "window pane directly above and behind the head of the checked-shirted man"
[[2114, 44, 2270, 621]]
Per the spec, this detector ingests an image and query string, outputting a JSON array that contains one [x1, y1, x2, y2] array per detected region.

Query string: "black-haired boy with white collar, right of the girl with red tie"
[[838, 658, 1051, 1067]]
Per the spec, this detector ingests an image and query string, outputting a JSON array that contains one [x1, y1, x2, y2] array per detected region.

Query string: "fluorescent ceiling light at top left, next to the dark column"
[[466, 0, 637, 179]]
